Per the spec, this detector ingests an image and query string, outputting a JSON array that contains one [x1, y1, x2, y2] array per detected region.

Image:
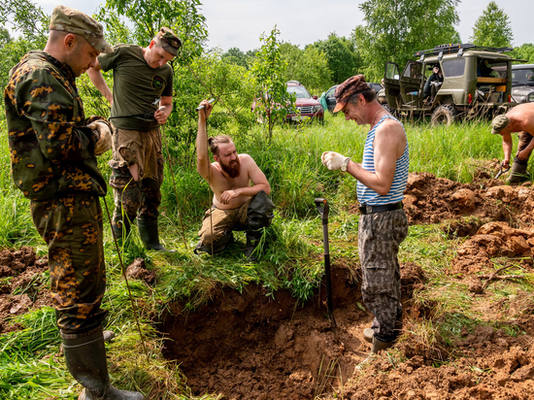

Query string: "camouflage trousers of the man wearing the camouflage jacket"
[[31, 195, 107, 333]]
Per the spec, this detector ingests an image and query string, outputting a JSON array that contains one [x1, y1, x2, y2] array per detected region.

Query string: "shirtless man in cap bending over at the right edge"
[[491, 103, 534, 185]]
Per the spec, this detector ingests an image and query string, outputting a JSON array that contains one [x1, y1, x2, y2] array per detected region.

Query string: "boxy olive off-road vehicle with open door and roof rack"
[[384, 43, 515, 125]]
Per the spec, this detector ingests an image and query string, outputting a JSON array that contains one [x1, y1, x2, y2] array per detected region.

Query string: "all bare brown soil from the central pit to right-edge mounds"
[[162, 173, 534, 400]]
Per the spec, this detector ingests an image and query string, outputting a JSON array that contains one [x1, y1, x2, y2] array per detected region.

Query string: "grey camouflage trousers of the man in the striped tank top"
[[358, 209, 408, 342]]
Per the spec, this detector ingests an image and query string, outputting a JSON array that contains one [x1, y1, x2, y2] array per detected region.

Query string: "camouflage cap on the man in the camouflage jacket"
[[50, 6, 112, 53]]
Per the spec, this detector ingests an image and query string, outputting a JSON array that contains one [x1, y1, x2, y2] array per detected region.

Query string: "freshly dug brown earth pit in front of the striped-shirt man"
[[163, 264, 424, 400]]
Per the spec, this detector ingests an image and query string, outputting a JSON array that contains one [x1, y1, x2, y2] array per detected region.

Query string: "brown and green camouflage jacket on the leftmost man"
[[4, 51, 106, 200]]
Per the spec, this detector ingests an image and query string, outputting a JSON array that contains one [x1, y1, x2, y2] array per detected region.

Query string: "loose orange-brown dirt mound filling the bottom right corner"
[[344, 322, 534, 400]]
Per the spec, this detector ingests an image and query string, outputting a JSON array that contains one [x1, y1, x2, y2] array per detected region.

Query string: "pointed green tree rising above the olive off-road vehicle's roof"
[[471, 1, 513, 47]]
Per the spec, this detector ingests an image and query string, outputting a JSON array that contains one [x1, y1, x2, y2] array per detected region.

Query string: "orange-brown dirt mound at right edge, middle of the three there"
[[452, 222, 534, 274]]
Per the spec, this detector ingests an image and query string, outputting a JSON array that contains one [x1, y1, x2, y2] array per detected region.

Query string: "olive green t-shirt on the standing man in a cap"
[[98, 44, 172, 130]]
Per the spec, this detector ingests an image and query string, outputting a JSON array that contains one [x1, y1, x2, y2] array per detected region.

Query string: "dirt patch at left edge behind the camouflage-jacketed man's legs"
[[0, 247, 49, 333]]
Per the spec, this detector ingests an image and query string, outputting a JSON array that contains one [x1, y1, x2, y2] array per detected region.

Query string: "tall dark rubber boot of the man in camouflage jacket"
[[61, 328, 145, 400]]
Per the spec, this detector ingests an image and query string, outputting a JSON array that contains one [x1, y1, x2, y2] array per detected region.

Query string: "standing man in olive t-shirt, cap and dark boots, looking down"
[[87, 28, 181, 251]]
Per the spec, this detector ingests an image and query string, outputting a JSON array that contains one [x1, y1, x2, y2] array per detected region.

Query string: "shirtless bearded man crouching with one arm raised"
[[195, 100, 274, 257]]
